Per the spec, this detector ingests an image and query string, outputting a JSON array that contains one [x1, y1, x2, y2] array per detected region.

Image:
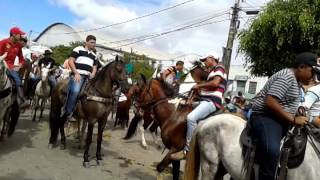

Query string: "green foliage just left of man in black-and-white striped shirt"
[[51, 42, 83, 64]]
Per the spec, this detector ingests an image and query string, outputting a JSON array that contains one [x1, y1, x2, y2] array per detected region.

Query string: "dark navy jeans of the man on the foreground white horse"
[[250, 114, 289, 180]]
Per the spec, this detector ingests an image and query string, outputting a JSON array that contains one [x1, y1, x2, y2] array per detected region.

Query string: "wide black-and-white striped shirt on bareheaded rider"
[[71, 46, 97, 75]]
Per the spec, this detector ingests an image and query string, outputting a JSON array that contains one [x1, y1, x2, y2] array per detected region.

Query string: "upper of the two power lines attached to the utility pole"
[[109, 11, 228, 44]]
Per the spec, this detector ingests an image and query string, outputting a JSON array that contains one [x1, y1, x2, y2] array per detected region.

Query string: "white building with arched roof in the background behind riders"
[[34, 23, 175, 64]]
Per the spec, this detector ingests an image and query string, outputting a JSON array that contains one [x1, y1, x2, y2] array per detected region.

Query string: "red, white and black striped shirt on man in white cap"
[[200, 64, 227, 108]]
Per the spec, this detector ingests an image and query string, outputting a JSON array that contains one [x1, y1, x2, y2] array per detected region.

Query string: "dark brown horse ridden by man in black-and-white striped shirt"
[[49, 56, 126, 167]]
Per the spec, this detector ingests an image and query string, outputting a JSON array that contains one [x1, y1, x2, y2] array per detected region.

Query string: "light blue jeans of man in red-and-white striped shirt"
[[185, 101, 217, 151]]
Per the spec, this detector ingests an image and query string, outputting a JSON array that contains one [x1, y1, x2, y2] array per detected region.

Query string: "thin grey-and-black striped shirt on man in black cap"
[[252, 68, 300, 115]]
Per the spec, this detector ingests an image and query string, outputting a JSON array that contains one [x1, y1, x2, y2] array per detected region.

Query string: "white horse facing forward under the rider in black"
[[32, 64, 52, 121]]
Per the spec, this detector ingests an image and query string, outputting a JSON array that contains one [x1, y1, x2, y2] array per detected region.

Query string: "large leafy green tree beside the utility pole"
[[238, 0, 320, 77]]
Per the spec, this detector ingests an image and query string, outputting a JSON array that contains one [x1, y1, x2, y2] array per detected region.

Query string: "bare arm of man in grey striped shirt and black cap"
[[265, 95, 294, 124]]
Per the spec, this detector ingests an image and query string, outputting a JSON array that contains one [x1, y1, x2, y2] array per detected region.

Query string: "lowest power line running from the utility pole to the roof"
[[113, 18, 230, 49]]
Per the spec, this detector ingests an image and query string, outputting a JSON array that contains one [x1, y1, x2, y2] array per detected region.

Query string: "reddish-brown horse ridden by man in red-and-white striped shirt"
[[132, 75, 192, 180]]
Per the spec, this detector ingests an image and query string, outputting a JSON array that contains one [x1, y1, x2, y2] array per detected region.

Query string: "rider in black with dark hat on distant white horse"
[[38, 50, 58, 89]]
